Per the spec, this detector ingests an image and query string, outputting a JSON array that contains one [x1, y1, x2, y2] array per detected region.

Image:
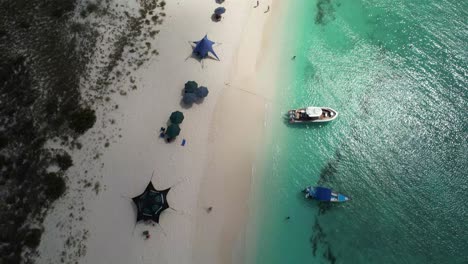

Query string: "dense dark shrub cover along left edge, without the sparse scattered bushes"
[[0, 0, 95, 264]]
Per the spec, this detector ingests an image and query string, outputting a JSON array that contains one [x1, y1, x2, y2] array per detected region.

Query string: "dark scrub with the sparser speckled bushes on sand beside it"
[[0, 0, 165, 264]]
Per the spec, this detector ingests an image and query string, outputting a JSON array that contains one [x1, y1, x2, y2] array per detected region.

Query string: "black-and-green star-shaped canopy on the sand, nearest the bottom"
[[132, 182, 171, 223]]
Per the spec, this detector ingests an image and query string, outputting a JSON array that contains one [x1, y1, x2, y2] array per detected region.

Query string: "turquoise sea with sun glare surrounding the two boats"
[[248, 0, 468, 263]]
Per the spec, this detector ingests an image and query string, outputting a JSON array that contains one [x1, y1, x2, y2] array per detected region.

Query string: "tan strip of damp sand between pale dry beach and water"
[[193, 1, 279, 263]]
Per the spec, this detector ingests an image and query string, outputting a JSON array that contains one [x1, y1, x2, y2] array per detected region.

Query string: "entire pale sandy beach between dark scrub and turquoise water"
[[38, 0, 276, 264]]
